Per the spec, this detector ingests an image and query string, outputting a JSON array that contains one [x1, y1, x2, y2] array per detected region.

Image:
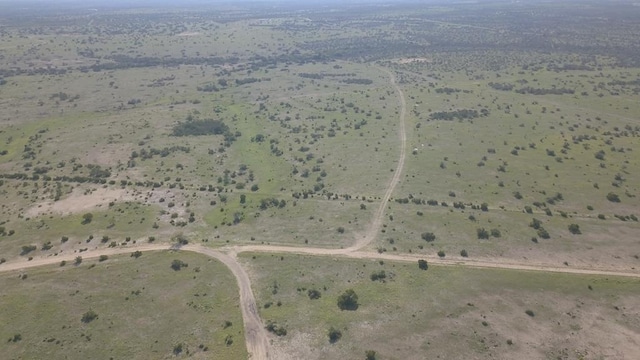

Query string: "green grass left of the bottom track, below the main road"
[[0, 252, 247, 359]]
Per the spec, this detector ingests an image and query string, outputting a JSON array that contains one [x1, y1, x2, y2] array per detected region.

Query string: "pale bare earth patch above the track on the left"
[[26, 188, 133, 217]]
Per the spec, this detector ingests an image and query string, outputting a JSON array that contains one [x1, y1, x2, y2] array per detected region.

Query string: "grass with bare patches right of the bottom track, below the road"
[[241, 254, 640, 359]]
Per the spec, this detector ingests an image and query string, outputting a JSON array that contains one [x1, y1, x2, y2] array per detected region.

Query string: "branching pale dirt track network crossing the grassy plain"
[[0, 69, 640, 360]]
